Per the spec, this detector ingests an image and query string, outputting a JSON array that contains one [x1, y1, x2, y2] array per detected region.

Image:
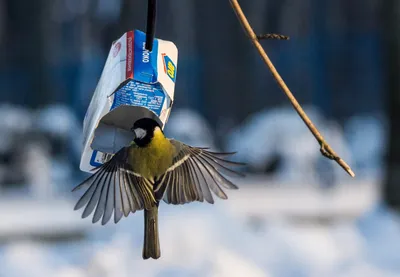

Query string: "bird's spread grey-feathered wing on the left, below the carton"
[[72, 147, 155, 225]]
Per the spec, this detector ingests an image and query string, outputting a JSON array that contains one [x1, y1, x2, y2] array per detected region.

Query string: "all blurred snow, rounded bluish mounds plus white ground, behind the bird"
[[0, 106, 400, 277]]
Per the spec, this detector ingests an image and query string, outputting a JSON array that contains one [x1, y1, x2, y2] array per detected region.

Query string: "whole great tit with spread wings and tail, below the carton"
[[73, 118, 244, 259]]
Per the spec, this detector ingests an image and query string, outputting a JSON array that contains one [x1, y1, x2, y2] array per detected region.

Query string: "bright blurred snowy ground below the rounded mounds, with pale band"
[[0, 177, 400, 277]]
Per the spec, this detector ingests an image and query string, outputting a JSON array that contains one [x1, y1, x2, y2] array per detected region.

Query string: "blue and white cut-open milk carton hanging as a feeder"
[[80, 30, 178, 172]]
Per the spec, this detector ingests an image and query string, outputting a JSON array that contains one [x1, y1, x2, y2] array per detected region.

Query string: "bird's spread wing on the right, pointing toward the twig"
[[154, 139, 244, 205]]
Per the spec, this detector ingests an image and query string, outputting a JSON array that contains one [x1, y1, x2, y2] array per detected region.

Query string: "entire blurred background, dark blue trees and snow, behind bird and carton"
[[0, 0, 400, 277]]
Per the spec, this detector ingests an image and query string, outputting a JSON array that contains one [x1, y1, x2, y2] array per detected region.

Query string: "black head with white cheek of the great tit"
[[131, 118, 162, 147]]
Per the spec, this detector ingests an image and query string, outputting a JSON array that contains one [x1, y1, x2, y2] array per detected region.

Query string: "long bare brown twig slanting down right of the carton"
[[230, 0, 355, 177]]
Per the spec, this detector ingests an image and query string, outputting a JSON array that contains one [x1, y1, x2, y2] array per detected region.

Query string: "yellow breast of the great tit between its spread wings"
[[129, 128, 174, 181]]
